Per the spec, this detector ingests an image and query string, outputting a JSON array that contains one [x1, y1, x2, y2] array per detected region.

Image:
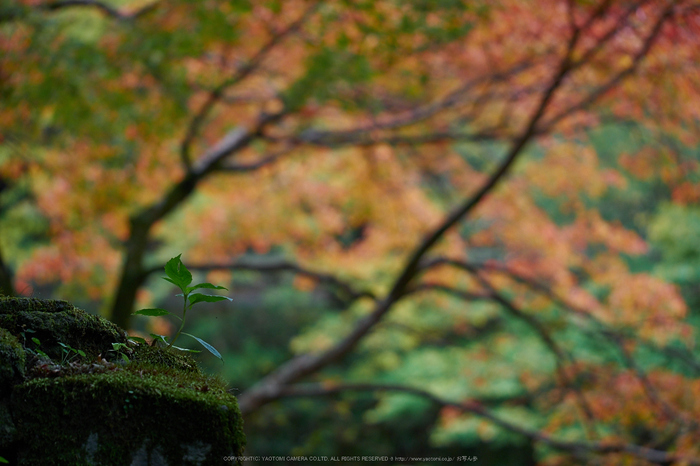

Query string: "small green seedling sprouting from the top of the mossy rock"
[[130, 254, 232, 362]]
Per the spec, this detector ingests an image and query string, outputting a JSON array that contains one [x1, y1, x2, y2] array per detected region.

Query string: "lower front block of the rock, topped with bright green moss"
[[12, 368, 245, 465]]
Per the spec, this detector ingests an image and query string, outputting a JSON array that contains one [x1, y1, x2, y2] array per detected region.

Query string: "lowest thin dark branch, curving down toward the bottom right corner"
[[280, 383, 700, 465]]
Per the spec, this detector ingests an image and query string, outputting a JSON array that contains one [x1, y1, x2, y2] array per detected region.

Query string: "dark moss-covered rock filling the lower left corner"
[[0, 298, 245, 466]]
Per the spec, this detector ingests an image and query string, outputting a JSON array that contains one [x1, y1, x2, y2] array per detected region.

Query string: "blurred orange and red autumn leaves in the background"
[[0, 0, 700, 464]]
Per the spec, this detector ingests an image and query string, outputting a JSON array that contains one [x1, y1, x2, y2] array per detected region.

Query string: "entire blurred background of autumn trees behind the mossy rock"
[[0, 0, 700, 465]]
